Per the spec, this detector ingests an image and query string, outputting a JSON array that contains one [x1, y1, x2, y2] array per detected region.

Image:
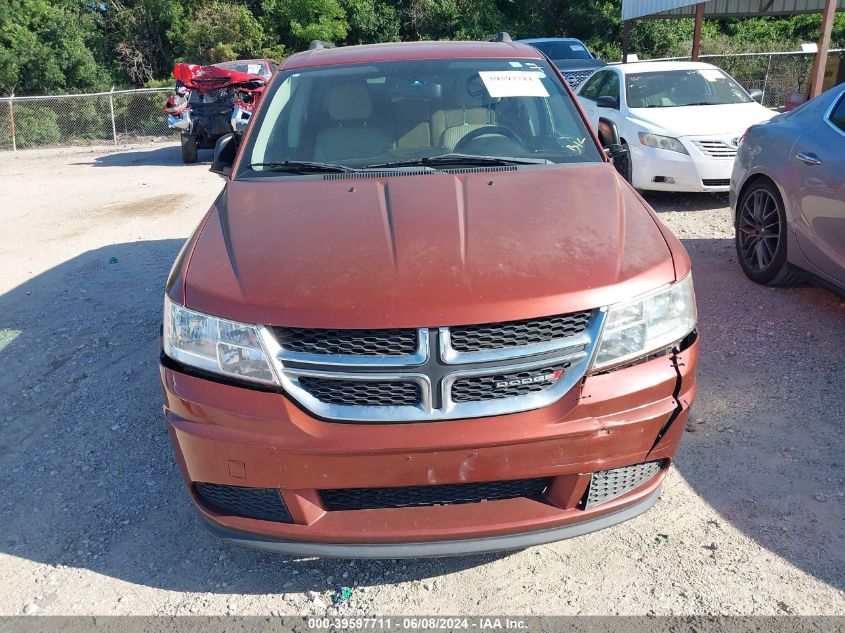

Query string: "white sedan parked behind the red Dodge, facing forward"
[[578, 62, 774, 192]]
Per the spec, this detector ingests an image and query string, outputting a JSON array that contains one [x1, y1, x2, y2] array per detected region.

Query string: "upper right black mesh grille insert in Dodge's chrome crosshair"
[[449, 312, 591, 352]]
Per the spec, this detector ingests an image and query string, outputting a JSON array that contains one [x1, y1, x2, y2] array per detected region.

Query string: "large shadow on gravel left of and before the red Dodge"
[[0, 239, 507, 594]]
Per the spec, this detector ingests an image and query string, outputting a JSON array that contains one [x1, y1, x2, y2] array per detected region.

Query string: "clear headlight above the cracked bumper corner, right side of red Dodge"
[[593, 274, 697, 369]]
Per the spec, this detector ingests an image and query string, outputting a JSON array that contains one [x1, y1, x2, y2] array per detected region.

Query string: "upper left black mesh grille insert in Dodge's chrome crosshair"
[[274, 327, 417, 356]]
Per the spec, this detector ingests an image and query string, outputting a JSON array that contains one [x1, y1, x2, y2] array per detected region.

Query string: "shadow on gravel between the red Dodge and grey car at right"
[[676, 239, 845, 590]]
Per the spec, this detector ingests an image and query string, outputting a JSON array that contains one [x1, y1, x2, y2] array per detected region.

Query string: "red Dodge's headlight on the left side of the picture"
[[164, 296, 278, 384]]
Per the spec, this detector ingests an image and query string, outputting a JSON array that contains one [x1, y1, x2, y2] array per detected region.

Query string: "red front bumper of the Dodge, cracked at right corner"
[[161, 343, 698, 558]]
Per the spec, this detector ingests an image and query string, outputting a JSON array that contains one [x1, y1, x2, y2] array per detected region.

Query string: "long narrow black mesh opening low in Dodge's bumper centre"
[[321, 477, 551, 510]]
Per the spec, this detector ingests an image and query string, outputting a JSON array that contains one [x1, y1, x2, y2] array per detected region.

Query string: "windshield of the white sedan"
[[625, 68, 751, 108]]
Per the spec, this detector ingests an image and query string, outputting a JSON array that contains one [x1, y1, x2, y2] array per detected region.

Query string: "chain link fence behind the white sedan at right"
[[643, 48, 845, 108]]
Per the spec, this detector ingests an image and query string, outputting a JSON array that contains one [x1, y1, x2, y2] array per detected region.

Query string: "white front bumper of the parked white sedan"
[[629, 142, 733, 193]]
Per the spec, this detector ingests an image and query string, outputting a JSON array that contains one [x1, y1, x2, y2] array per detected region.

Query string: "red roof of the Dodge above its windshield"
[[283, 42, 543, 70]]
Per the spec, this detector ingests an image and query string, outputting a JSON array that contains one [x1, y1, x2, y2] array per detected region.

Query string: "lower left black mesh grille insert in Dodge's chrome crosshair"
[[299, 376, 421, 406]]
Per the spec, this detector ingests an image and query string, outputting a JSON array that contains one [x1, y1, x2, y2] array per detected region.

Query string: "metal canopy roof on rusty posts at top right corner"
[[622, 0, 845, 20]]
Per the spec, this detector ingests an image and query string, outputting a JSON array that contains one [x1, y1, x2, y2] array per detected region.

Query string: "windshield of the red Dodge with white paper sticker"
[[238, 59, 602, 175]]
